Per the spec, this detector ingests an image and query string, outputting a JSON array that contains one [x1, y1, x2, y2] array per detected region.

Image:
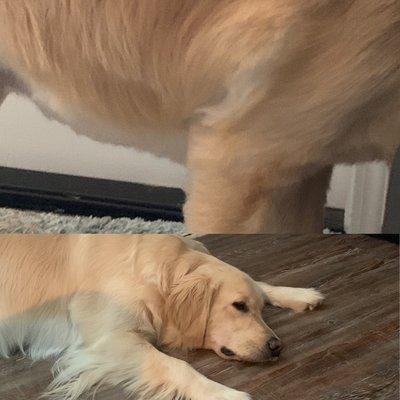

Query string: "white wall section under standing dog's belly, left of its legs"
[[0, 94, 186, 187]]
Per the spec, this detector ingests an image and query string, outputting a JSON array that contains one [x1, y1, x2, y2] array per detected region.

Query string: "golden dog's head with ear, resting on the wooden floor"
[[162, 256, 282, 362]]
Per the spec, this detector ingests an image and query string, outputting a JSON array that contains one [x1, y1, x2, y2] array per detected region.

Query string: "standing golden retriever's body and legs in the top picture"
[[0, 0, 400, 233]]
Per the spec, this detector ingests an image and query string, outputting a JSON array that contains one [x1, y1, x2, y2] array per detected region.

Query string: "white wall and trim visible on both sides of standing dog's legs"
[[0, 94, 387, 233]]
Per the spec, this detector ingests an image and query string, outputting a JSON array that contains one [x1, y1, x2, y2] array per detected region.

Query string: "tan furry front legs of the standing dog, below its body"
[[185, 130, 332, 233]]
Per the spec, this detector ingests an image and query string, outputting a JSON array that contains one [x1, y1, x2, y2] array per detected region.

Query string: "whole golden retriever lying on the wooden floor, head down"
[[0, 235, 323, 400]]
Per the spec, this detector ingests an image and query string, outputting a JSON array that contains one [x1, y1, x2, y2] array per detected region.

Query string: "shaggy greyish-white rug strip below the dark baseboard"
[[0, 208, 185, 234]]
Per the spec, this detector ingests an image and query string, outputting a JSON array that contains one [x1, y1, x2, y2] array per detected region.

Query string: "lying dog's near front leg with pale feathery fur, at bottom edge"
[[48, 332, 250, 400]]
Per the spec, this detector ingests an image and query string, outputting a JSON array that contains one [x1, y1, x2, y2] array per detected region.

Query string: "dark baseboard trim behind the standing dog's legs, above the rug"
[[0, 167, 344, 232]]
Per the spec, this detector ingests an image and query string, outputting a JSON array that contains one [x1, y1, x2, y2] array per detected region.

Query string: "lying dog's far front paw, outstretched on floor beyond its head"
[[257, 282, 324, 312]]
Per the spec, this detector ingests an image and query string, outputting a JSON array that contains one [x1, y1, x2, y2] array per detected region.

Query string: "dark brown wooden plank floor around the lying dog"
[[0, 235, 399, 400]]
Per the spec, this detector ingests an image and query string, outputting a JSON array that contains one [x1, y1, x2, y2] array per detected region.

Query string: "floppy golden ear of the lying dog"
[[166, 271, 217, 348]]
